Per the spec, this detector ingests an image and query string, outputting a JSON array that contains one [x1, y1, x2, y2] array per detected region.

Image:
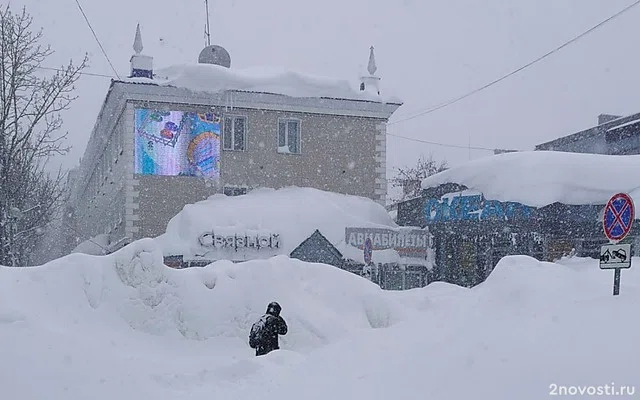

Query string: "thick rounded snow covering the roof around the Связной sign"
[[155, 187, 399, 261]]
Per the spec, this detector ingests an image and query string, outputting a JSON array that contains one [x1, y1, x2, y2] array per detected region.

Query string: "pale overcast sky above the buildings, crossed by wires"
[[11, 0, 640, 178]]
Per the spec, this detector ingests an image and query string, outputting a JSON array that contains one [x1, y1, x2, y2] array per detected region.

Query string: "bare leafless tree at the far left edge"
[[0, 6, 87, 266]]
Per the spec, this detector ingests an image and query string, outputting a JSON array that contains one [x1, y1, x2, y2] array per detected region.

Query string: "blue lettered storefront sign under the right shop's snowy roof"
[[424, 194, 534, 224]]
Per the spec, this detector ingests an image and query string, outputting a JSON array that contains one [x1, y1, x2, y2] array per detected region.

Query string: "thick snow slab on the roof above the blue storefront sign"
[[422, 151, 640, 207]]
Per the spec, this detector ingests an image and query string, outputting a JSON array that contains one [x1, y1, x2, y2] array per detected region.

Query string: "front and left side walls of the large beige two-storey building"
[[65, 78, 400, 248]]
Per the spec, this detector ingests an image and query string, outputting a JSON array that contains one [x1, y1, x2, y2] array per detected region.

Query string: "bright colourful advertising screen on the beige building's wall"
[[135, 108, 220, 178]]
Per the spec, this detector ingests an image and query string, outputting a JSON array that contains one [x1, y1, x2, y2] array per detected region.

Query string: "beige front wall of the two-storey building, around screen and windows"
[[125, 102, 386, 238]]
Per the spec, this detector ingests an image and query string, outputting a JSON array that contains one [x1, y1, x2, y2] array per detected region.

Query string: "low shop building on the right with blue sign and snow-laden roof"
[[397, 151, 640, 286]]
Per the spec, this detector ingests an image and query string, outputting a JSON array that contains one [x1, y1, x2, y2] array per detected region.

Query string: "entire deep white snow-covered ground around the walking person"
[[0, 239, 640, 400]]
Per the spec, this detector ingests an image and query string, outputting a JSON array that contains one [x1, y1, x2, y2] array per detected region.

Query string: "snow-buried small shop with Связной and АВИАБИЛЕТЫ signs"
[[154, 187, 433, 290]]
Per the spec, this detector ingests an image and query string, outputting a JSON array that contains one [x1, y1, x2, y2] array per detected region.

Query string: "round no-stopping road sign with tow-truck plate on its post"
[[600, 193, 635, 296]]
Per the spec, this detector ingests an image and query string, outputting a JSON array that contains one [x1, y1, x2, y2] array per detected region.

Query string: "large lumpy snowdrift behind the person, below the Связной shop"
[[0, 239, 403, 350]]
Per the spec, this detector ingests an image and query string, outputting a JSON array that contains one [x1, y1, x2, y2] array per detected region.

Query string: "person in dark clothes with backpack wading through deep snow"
[[249, 301, 288, 356]]
